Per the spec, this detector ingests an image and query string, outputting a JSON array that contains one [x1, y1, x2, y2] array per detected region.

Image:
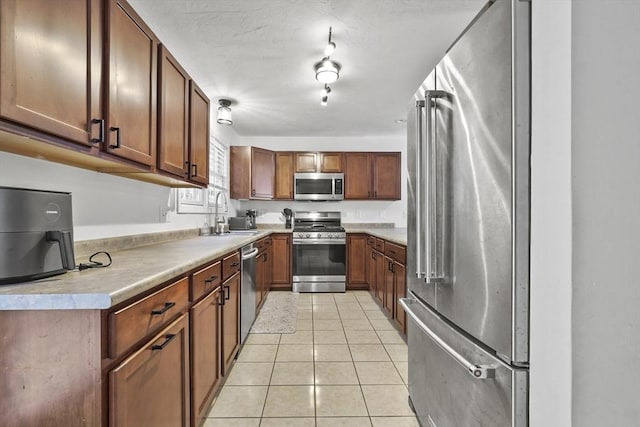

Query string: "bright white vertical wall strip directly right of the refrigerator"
[[530, 0, 572, 427]]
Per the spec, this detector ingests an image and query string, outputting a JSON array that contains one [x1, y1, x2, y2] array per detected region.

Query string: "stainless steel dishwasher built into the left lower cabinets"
[[240, 243, 258, 344]]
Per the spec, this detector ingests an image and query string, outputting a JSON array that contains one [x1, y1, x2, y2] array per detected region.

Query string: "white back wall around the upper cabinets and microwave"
[[233, 134, 407, 227]]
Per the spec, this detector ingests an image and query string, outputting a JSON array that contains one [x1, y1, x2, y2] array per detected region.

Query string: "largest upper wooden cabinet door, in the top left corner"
[[0, 0, 103, 145]]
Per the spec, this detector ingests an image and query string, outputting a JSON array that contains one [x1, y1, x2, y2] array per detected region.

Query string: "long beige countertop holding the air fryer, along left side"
[[0, 230, 272, 310]]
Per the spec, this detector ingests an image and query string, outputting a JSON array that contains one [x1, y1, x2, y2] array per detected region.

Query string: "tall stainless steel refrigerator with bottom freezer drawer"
[[401, 0, 531, 427]]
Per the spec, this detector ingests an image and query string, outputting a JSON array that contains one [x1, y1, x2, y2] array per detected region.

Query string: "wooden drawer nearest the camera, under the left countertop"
[[109, 277, 189, 358]]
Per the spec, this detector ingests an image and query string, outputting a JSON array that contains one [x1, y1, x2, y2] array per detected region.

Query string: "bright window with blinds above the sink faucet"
[[177, 137, 229, 214]]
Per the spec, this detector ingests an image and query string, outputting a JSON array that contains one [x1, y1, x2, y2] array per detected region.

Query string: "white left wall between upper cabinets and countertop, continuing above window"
[[0, 121, 237, 241]]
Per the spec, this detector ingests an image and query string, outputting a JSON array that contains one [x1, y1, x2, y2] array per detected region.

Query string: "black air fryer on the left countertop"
[[0, 187, 76, 284]]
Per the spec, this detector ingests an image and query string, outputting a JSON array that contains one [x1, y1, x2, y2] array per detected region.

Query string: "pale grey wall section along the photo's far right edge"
[[571, 0, 640, 427]]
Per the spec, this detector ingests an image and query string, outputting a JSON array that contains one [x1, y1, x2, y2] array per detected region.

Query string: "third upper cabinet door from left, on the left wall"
[[158, 46, 189, 178]]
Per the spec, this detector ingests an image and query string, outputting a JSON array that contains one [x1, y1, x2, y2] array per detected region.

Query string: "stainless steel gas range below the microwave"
[[293, 211, 347, 292]]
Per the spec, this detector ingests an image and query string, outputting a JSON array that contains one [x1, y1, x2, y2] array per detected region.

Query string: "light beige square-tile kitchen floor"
[[204, 291, 418, 427]]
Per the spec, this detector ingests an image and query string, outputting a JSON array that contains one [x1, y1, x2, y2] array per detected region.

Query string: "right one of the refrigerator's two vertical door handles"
[[424, 90, 449, 283]]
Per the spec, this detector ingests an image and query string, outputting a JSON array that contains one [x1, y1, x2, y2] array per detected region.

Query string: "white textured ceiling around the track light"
[[129, 0, 485, 136]]
